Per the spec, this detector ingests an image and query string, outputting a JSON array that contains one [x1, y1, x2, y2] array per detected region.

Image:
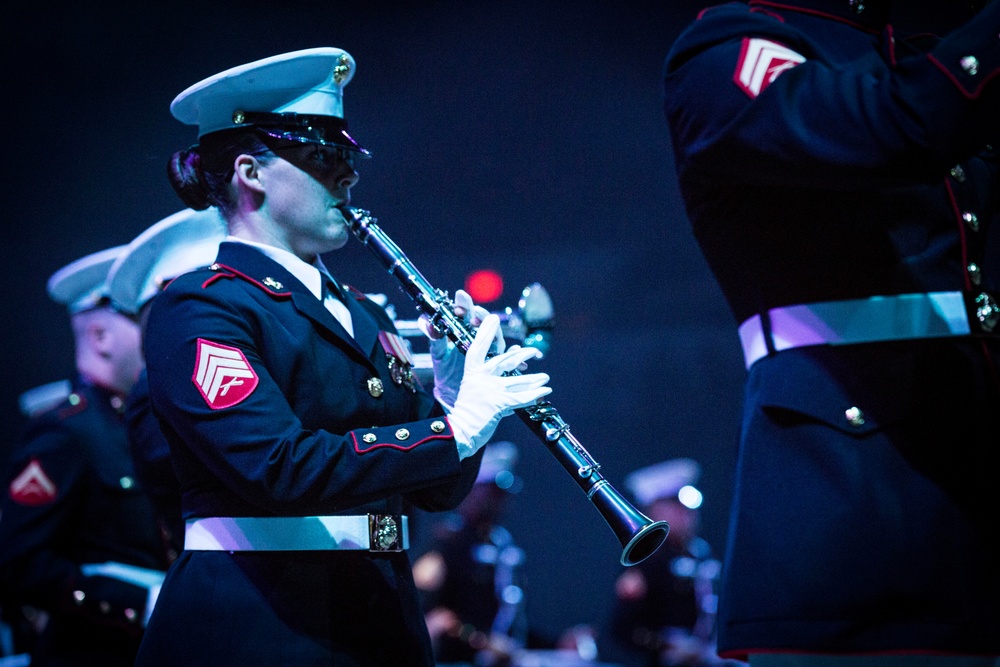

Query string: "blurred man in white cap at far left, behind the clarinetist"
[[0, 246, 169, 667]]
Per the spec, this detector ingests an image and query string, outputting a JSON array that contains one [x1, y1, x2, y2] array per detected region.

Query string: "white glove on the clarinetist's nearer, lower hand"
[[448, 314, 552, 460]]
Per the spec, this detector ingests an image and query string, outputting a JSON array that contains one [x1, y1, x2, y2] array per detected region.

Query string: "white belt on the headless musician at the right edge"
[[739, 292, 971, 368]]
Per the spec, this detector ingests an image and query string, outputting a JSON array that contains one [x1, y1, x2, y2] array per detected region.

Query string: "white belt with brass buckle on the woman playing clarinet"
[[184, 514, 410, 552]]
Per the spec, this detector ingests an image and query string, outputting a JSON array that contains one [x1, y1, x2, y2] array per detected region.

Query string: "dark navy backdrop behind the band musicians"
[[0, 0, 744, 656]]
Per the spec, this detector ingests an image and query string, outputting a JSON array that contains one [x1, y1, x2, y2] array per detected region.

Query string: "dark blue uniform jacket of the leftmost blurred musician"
[[0, 382, 168, 665]]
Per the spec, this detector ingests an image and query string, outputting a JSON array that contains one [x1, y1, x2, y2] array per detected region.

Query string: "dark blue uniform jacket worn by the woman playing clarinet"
[[138, 243, 481, 665]]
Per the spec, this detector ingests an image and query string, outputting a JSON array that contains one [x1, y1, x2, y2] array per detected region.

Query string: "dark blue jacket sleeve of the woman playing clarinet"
[[146, 286, 474, 514]]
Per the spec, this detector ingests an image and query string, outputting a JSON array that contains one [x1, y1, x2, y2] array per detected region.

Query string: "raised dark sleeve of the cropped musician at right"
[[664, 3, 1000, 188]]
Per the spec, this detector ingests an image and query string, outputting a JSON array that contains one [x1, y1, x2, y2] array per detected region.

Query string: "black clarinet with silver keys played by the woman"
[[342, 207, 670, 566]]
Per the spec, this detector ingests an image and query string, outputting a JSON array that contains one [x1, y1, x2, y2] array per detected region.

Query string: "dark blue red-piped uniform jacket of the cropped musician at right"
[[664, 0, 1000, 657]]
